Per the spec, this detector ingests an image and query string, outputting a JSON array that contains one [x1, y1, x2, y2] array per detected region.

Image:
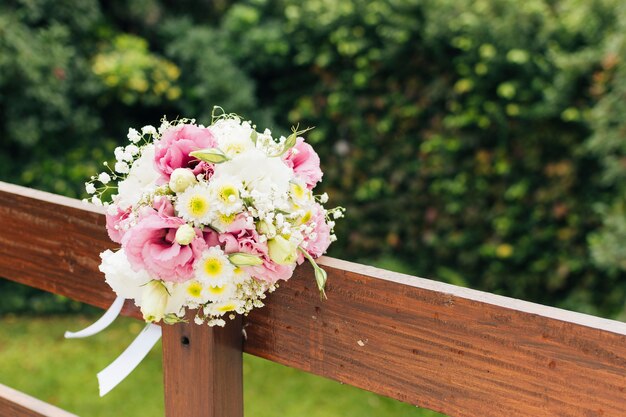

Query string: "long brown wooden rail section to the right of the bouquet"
[[244, 258, 626, 417]]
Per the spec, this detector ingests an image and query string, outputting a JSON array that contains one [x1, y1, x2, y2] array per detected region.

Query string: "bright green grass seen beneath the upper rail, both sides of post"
[[0, 316, 440, 417]]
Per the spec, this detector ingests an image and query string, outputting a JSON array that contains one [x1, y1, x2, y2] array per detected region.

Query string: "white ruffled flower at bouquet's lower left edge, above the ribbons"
[[99, 249, 151, 305]]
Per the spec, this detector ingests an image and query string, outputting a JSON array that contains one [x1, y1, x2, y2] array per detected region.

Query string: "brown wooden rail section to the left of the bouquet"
[[0, 182, 141, 318]]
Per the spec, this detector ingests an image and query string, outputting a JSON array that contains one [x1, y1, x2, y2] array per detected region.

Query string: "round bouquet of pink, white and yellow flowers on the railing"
[[85, 108, 344, 326]]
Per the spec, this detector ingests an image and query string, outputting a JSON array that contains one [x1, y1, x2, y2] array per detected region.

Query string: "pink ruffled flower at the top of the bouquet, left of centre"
[[154, 124, 217, 184]]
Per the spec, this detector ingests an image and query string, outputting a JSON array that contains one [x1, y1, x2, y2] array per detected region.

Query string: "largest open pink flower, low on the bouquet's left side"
[[122, 198, 207, 282]]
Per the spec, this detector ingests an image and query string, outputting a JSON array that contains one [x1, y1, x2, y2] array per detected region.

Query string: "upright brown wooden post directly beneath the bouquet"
[[163, 315, 243, 417]]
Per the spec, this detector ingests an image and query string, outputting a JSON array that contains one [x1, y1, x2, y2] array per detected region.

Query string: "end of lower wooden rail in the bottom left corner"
[[0, 384, 77, 417]]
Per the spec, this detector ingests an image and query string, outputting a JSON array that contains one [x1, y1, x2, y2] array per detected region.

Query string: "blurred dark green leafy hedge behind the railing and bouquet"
[[0, 0, 626, 319]]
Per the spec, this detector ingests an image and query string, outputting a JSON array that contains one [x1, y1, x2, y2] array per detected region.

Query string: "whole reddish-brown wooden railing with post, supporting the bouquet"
[[0, 183, 626, 417]]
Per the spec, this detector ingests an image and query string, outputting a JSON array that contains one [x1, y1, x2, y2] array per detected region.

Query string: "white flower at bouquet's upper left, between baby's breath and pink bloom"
[[115, 145, 159, 210]]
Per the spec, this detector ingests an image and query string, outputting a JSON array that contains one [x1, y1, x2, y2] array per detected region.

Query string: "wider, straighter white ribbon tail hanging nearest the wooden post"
[[98, 324, 161, 397]]
